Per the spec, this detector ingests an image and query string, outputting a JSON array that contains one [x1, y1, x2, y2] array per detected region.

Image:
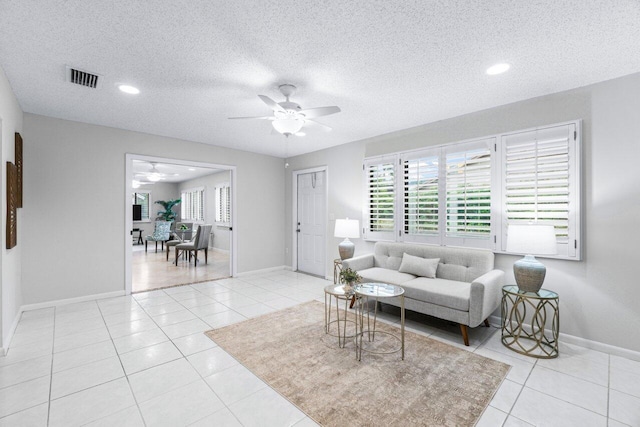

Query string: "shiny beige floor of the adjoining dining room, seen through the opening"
[[131, 242, 229, 292]]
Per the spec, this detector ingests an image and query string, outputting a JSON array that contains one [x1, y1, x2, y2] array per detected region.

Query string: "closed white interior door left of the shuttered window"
[[297, 171, 327, 277]]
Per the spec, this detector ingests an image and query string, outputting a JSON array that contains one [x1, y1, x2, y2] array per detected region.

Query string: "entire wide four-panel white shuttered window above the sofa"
[[363, 121, 580, 259]]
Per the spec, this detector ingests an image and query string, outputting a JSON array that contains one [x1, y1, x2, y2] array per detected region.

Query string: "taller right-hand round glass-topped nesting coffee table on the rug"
[[355, 283, 404, 360]]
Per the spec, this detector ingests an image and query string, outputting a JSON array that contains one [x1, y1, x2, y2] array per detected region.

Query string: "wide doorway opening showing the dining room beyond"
[[125, 154, 237, 294]]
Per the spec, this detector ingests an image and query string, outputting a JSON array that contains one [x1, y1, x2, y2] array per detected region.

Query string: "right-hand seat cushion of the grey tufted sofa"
[[399, 277, 471, 311]]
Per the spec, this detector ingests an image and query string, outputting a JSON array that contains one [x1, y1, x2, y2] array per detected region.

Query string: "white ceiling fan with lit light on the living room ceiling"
[[229, 84, 340, 137]]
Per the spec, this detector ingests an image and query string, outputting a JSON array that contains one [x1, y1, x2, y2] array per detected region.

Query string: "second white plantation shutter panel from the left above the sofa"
[[402, 149, 440, 243]]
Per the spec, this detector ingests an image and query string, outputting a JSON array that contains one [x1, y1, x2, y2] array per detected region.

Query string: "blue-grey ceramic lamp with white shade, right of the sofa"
[[507, 224, 558, 292]]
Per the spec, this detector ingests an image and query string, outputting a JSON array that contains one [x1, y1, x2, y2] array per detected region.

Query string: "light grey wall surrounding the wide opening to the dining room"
[[22, 114, 284, 304]]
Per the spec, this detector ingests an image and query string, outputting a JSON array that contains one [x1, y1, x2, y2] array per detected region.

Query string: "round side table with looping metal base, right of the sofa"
[[501, 285, 560, 359]]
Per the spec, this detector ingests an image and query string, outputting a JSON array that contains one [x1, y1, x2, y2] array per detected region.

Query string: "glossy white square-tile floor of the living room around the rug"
[[0, 271, 640, 427]]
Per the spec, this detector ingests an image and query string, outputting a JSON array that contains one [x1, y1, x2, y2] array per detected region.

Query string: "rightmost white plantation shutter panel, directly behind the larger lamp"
[[502, 123, 579, 258]]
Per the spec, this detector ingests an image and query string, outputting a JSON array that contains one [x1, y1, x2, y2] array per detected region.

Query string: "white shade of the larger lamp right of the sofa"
[[507, 224, 558, 255]]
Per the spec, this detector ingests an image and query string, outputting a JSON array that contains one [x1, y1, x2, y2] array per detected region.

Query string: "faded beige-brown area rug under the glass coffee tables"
[[206, 301, 510, 427]]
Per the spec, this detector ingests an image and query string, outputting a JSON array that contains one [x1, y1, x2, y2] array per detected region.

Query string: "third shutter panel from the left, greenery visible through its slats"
[[443, 138, 494, 248]]
